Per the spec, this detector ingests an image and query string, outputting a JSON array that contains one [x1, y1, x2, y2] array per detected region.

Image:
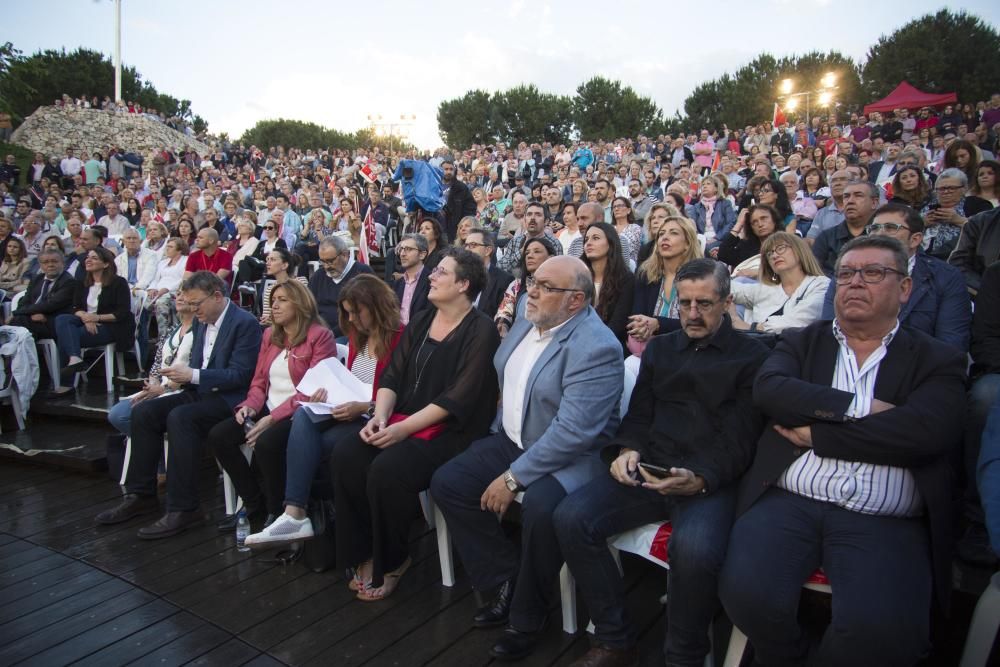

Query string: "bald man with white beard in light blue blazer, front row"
[[431, 256, 624, 660]]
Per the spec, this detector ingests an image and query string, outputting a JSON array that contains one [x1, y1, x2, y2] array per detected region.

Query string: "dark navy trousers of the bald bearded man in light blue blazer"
[[431, 433, 566, 632]]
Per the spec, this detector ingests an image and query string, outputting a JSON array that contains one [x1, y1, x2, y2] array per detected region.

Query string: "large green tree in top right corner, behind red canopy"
[[862, 9, 1000, 102]]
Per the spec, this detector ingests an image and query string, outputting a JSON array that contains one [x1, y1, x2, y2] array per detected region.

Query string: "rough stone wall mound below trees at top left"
[[11, 107, 211, 164]]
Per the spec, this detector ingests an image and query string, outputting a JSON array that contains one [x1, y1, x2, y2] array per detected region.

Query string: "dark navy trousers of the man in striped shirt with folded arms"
[[720, 488, 932, 667]]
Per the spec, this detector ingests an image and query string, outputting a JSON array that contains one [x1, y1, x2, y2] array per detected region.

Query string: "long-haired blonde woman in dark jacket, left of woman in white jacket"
[[626, 216, 702, 352]]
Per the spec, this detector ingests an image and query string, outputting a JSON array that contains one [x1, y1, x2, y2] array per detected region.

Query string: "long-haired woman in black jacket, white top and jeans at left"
[[52, 248, 135, 396]]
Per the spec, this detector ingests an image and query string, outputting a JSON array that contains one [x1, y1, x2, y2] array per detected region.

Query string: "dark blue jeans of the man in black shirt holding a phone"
[[554, 475, 735, 666]]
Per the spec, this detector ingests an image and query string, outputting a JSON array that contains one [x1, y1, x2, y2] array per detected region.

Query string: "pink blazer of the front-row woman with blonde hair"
[[236, 324, 337, 421]]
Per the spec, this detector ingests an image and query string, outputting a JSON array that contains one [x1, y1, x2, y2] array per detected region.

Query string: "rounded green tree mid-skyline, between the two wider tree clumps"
[[573, 76, 663, 139]]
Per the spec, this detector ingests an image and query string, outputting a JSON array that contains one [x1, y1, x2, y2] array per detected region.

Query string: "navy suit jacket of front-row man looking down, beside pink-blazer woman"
[[191, 302, 261, 408]]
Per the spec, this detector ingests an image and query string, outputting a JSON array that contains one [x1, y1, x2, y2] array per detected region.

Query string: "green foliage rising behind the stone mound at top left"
[[0, 43, 201, 131]]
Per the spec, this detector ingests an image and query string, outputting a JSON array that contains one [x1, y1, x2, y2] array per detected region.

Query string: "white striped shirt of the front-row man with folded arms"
[[777, 320, 923, 517]]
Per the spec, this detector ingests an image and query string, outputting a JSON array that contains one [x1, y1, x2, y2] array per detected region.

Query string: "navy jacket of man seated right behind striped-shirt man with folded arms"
[[820, 252, 972, 351]]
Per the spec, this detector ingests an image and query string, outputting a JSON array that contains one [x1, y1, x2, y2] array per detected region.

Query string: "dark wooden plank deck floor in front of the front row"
[[0, 422, 988, 667]]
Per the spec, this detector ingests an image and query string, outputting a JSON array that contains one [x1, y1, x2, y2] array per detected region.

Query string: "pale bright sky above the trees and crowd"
[[7, 0, 1000, 148]]
